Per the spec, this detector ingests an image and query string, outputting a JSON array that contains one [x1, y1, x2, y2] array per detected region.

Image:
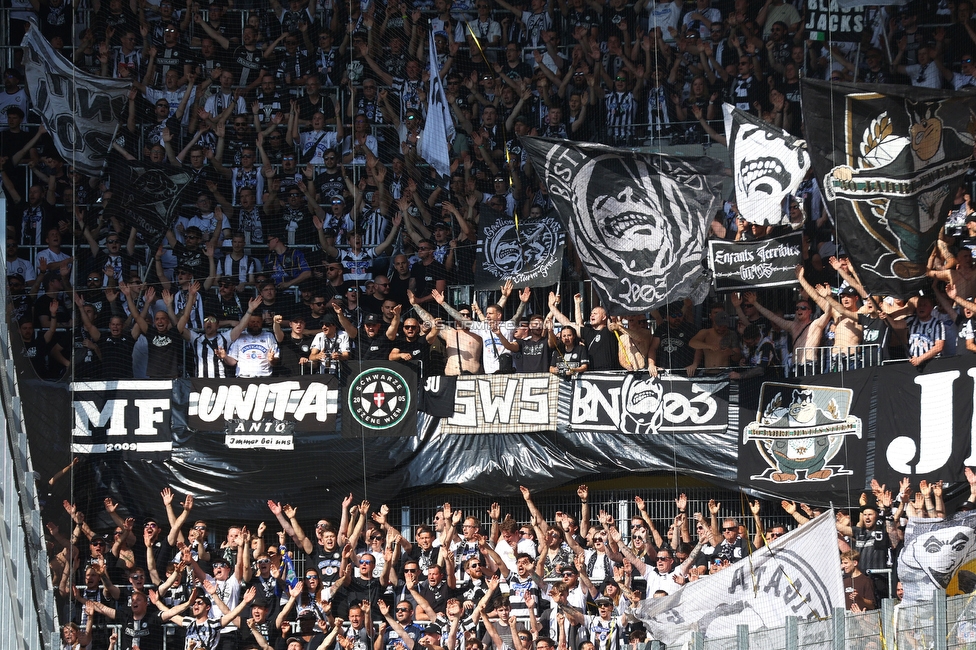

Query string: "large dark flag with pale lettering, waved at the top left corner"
[[22, 22, 132, 176]]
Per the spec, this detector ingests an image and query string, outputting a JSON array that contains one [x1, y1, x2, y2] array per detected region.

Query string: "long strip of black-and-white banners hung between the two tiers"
[[18, 350, 976, 516]]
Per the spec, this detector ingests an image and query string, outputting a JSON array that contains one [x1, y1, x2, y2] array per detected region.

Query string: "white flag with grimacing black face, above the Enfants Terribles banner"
[[722, 104, 810, 225]]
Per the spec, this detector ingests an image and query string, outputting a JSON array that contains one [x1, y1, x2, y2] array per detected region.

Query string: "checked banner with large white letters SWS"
[[440, 374, 559, 435]]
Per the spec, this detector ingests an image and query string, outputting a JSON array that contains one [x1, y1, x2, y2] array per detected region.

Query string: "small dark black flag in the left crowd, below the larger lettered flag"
[[109, 153, 191, 251]]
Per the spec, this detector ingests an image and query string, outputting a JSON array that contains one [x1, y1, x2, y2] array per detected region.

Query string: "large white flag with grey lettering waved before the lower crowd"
[[635, 511, 844, 648]]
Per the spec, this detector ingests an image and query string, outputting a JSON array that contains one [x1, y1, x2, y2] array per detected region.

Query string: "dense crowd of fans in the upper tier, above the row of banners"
[[0, 0, 976, 378]]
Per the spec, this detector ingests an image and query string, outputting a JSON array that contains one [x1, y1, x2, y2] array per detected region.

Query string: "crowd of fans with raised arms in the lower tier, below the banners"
[[53, 469, 976, 650]]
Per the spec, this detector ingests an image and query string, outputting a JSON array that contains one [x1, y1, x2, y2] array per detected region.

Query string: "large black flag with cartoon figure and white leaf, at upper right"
[[803, 80, 976, 297]]
